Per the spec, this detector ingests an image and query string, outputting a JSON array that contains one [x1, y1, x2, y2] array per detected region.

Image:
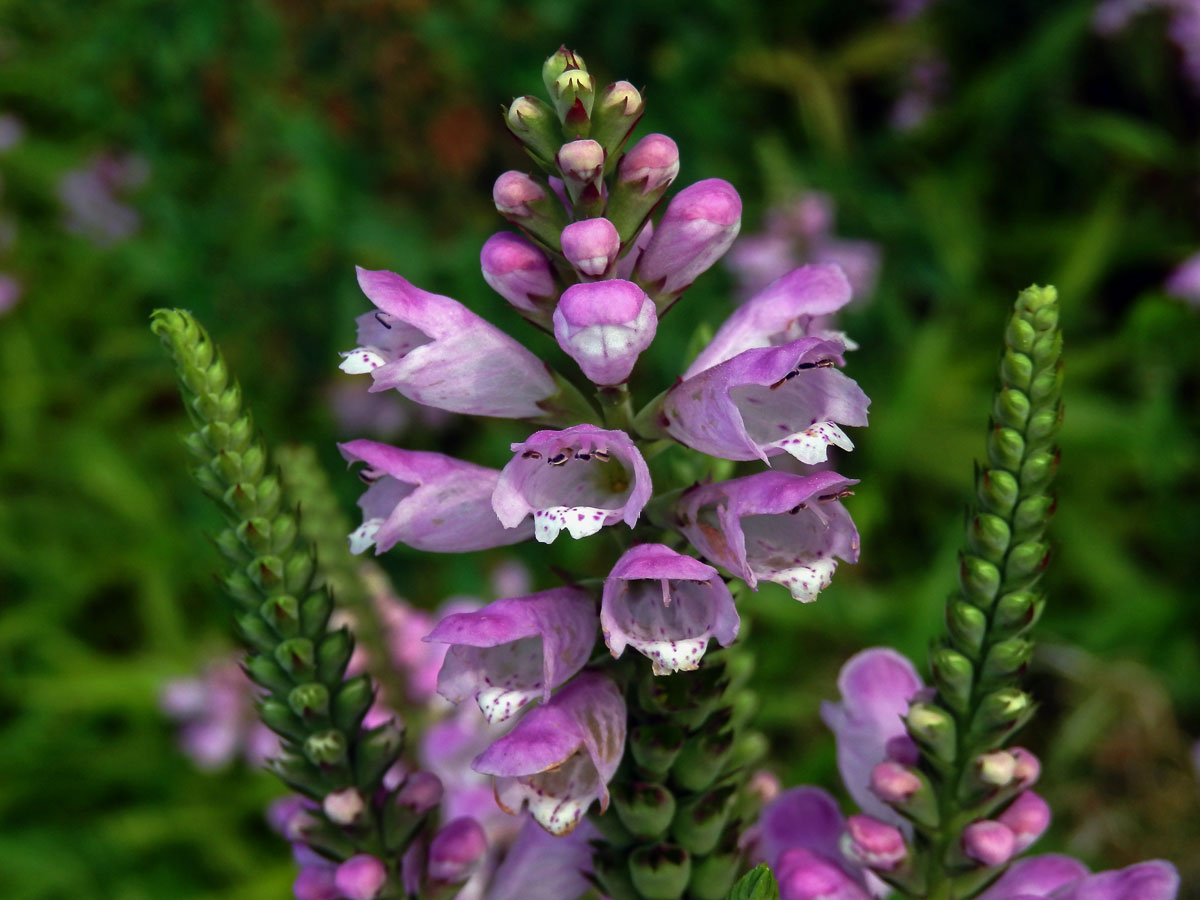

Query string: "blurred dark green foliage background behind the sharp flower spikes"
[[0, 0, 1200, 900]]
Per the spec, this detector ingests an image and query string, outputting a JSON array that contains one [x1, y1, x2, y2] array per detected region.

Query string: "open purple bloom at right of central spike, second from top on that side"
[[662, 337, 871, 466]]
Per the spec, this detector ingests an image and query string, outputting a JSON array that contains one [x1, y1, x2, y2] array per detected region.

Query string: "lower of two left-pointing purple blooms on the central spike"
[[337, 440, 530, 554]]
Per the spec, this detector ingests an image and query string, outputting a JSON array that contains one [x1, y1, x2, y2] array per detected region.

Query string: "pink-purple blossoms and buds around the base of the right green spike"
[[758, 648, 1178, 900]]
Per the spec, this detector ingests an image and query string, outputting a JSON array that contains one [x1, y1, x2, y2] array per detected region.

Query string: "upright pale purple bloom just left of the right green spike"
[[821, 647, 924, 828]]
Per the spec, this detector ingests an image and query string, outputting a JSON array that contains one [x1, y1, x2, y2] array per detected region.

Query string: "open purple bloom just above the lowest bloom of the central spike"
[[425, 588, 596, 724]]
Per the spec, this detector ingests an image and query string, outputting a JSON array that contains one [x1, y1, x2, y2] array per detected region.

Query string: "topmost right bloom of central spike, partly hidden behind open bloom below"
[[683, 265, 851, 379]]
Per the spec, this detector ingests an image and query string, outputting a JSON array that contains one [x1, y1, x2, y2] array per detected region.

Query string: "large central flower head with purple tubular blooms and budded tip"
[[341, 49, 869, 835]]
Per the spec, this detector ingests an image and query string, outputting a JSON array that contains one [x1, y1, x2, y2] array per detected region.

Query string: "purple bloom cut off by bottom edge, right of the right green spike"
[[978, 854, 1180, 900]]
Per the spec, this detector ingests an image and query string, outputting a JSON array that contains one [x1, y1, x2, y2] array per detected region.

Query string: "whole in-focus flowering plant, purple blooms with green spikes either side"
[[154, 49, 1177, 900]]
